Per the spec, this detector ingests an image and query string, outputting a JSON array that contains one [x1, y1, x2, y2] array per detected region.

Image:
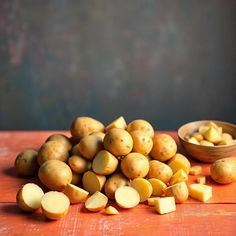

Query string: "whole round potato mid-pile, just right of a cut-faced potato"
[[121, 152, 149, 179]]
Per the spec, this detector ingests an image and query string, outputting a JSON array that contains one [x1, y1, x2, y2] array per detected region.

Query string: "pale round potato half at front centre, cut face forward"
[[115, 186, 140, 208]]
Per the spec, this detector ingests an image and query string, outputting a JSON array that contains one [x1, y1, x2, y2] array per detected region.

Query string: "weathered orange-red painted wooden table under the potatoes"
[[0, 131, 236, 236]]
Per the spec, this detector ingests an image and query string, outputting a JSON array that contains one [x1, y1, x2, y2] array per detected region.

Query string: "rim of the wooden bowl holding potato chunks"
[[177, 120, 236, 149]]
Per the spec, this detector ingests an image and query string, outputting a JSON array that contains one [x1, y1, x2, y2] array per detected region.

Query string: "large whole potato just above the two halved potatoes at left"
[[38, 159, 72, 191]]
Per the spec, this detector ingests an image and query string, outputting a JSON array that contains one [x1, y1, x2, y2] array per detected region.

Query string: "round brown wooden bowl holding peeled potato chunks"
[[178, 120, 236, 163]]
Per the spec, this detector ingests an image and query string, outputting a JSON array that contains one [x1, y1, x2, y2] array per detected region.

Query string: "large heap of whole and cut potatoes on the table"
[[15, 117, 236, 220]]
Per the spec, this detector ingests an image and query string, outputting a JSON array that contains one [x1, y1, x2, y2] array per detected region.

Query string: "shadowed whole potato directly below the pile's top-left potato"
[[78, 134, 103, 160]]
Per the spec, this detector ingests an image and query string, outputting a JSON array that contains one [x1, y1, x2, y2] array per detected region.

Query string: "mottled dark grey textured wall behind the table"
[[0, 0, 236, 129]]
